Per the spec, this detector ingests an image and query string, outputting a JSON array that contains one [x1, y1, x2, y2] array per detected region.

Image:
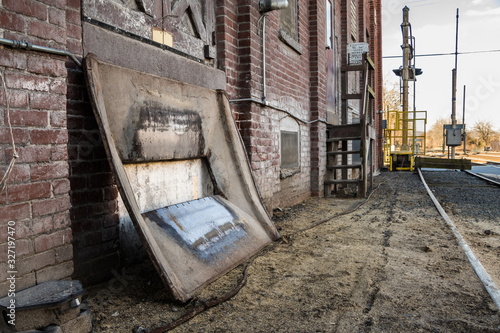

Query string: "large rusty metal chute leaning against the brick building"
[[85, 55, 279, 301]]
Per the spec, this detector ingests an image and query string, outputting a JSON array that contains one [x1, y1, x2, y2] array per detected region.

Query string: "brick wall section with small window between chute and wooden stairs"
[[217, 0, 316, 209]]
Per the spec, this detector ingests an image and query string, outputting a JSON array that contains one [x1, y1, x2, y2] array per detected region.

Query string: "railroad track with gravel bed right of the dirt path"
[[418, 169, 500, 309]]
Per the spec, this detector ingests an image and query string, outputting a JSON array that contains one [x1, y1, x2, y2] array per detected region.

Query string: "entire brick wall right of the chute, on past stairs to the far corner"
[[217, 0, 382, 208]]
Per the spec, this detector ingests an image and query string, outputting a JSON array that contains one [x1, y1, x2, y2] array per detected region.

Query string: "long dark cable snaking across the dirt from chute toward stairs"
[[139, 183, 383, 333]]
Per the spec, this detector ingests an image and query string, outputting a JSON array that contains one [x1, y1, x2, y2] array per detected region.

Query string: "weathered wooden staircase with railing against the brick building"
[[324, 53, 375, 197]]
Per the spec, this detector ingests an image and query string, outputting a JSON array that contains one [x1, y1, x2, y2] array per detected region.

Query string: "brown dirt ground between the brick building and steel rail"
[[85, 172, 500, 332]]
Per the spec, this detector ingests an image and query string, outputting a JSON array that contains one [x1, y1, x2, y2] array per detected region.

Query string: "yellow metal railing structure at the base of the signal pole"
[[384, 111, 427, 171]]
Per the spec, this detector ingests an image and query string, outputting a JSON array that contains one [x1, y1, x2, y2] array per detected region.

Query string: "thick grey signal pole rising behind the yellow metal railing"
[[401, 6, 412, 150]]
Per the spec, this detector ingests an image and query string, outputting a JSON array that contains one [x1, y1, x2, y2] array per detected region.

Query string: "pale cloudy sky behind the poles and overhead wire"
[[382, 0, 500, 130]]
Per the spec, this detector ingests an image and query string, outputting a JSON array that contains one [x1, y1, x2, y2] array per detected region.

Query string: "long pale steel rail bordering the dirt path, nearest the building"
[[417, 168, 500, 310]]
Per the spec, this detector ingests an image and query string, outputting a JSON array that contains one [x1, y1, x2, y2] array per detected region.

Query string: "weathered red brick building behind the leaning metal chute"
[[0, 0, 382, 296]]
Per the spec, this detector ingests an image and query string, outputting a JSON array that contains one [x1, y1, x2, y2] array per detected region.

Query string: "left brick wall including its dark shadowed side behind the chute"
[[0, 0, 119, 295]]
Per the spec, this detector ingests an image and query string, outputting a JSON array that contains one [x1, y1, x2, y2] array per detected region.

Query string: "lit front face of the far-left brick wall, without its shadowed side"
[[0, 0, 73, 296]]
